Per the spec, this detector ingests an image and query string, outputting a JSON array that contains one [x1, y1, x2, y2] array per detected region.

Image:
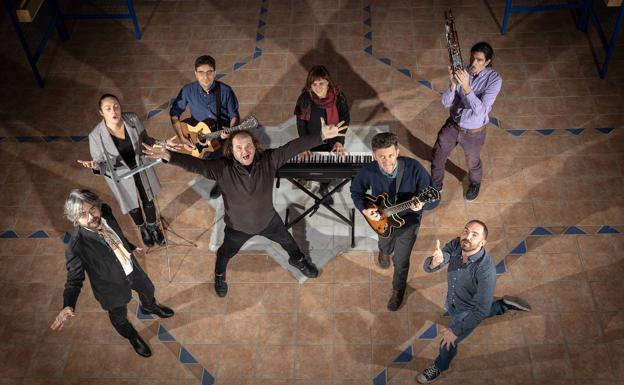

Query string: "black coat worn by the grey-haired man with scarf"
[[63, 204, 149, 310]]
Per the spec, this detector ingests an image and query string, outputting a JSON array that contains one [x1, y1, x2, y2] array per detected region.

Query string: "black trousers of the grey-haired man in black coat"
[[108, 266, 156, 339]]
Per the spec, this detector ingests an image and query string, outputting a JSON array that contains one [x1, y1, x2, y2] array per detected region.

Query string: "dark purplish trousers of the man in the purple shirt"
[[431, 118, 485, 189]]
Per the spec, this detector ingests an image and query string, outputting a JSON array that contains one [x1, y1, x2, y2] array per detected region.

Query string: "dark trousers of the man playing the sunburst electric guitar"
[[377, 224, 420, 290]]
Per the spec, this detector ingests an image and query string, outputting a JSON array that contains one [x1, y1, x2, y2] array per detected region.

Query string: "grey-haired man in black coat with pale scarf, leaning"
[[51, 189, 174, 357]]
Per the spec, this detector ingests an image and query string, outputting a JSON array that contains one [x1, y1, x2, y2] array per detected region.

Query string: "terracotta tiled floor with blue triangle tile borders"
[[0, 0, 624, 385]]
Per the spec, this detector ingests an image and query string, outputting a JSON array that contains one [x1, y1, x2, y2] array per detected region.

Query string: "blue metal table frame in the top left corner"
[[4, 0, 141, 88]]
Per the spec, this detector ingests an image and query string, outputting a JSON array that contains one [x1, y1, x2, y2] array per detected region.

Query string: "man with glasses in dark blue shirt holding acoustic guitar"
[[169, 55, 240, 199]]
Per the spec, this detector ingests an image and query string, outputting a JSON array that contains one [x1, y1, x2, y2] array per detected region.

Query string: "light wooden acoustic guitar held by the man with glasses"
[[180, 116, 258, 158]]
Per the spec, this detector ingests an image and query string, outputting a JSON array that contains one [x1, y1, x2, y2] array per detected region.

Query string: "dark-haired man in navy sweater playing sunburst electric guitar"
[[351, 132, 438, 311]]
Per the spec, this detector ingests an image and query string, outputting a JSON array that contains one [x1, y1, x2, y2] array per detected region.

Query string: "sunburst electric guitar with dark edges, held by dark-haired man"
[[364, 186, 440, 238]]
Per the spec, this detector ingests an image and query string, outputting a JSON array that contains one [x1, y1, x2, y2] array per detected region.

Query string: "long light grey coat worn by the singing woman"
[[89, 112, 160, 214]]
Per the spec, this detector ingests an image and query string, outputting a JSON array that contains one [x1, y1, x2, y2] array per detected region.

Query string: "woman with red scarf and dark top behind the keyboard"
[[295, 65, 350, 200]]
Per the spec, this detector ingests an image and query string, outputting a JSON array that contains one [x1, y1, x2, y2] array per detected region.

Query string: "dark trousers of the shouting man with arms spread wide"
[[215, 212, 305, 275]]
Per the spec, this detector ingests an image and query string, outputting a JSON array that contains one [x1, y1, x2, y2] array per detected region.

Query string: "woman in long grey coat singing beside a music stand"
[[78, 94, 165, 247]]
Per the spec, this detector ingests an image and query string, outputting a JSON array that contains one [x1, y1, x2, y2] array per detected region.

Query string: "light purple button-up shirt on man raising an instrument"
[[442, 67, 503, 129]]
